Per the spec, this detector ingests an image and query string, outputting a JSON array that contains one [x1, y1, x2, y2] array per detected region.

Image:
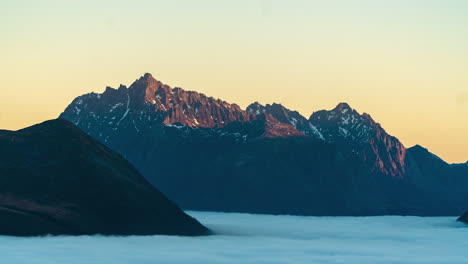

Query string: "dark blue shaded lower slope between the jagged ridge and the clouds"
[[108, 123, 414, 215]]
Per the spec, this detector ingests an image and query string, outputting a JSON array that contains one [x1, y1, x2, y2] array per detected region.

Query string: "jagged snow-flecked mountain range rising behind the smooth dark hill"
[[61, 74, 468, 215]]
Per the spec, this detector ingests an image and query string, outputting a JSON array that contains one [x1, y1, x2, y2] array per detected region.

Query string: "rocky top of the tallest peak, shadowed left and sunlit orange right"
[[63, 73, 253, 134]]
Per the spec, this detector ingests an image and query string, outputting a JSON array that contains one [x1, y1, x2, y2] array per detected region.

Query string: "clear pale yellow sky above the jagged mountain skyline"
[[0, 0, 468, 163]]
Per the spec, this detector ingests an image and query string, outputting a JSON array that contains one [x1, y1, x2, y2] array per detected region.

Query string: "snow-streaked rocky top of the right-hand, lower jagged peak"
[[247, 103, 406, 177]]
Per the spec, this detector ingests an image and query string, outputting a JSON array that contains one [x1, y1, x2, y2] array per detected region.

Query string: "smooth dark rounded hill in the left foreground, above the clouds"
[[0, 119, 208, 236]]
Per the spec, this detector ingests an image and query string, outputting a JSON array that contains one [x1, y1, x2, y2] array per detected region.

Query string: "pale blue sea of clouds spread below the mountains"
[[0, 212, 468, 264]]
